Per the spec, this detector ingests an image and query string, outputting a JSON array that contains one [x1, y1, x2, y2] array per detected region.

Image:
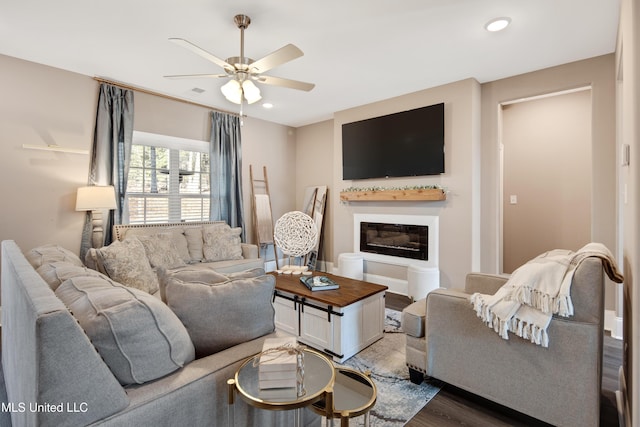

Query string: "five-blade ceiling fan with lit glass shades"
[[165, 15, 315, 105]]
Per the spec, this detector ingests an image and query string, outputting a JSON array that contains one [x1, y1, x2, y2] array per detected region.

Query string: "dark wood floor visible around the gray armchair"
[[385, 293, 622, 427]]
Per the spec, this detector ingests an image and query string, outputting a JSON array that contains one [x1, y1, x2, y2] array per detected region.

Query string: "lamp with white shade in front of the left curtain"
[[76, 185, 117, 248]]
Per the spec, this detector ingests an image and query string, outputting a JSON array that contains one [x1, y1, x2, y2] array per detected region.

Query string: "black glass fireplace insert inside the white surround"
[[360, 221, 429, 261]]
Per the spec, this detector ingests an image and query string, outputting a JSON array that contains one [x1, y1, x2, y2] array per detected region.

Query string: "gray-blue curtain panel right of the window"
[[209, 111, 246, 242]]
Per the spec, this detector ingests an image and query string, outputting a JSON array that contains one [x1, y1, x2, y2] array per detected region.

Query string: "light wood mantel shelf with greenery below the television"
[[340, 185, 447, 202]]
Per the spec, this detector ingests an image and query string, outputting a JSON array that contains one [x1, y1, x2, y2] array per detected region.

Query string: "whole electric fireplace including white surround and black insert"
[[353, 214, 439, 267]]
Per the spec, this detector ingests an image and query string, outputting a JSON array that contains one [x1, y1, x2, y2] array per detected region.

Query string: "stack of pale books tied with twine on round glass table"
[[258, 337, 298, 395]]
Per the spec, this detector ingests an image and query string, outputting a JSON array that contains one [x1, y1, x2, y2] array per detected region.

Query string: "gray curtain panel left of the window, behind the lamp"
[[80, 83, 133, 259]]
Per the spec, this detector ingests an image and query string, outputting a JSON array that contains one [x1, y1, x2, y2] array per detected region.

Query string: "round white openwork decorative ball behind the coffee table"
[[273, 211, 318, 256]]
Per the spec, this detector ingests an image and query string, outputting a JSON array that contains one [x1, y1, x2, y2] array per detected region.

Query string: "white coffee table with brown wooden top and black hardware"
[[271, 272, 388, 362]]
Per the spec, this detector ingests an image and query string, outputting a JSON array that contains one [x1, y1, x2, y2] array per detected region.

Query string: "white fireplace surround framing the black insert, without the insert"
[[353, 214, 440, 268]]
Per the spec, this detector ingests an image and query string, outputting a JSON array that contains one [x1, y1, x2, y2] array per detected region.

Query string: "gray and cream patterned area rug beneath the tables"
[[332, 309, 440, 427]]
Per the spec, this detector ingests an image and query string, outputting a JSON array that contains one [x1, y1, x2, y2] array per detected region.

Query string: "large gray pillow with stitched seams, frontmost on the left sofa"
[[56, 276, 194, 385]]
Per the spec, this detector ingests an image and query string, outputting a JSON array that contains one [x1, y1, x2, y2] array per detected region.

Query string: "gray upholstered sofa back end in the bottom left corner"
[[1, 240, 129, 426]]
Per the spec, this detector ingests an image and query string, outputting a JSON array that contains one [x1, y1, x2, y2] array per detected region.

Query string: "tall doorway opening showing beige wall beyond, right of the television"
[[501, 88, 592, 273]]
